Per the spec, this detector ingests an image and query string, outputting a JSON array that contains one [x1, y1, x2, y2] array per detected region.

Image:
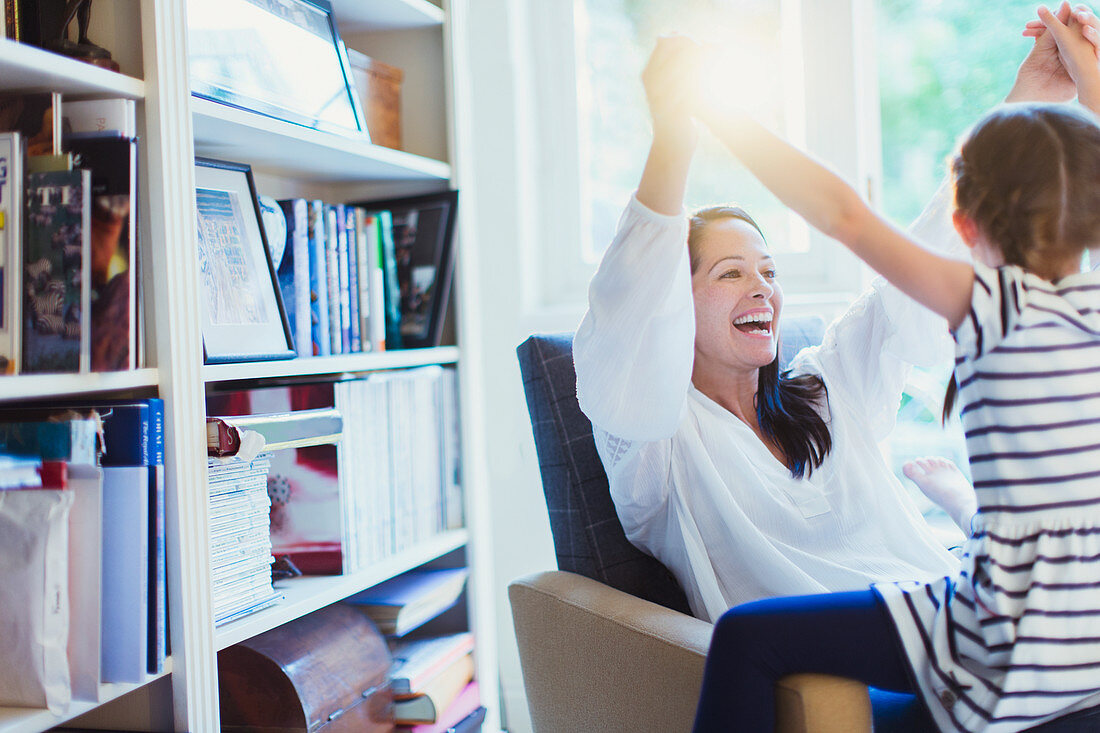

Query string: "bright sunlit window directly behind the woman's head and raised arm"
[[557, 0, 862, 311]]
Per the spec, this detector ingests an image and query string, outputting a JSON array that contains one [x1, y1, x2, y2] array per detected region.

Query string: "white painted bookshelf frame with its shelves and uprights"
[[0, 0, 499, 733]]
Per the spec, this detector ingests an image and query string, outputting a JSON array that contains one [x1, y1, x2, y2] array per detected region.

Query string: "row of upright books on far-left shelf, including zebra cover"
[[0, 94, 141, 373]]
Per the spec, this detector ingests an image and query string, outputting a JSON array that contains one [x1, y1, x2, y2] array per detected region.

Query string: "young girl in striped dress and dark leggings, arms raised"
[[695, 9, 1100, 733]]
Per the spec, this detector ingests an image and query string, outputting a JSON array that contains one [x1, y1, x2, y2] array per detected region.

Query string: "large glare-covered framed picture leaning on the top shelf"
[[187, 0, 369, 136]]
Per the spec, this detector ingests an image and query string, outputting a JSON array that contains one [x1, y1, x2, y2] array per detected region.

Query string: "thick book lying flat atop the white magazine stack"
[[207, 408, 343, 456]]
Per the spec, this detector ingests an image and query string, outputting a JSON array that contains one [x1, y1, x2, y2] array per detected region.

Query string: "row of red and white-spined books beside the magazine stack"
[[207, 367, 463, 575]]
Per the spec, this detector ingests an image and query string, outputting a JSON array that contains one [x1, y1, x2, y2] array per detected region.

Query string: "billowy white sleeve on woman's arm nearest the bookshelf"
[[573, 193, 695, 442]]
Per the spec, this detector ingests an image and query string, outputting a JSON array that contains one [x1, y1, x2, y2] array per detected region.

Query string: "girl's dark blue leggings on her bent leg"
[[694, 590, 914, 733]]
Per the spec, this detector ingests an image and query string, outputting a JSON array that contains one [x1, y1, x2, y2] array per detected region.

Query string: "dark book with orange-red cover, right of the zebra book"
[[65, 136, 138, 372]]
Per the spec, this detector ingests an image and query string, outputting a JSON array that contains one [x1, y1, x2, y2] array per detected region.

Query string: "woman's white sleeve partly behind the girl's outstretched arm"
[[791, 182, 969, 439]]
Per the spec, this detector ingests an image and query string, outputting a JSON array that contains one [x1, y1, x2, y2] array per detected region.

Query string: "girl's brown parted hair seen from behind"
[[944, 105, 1100, 422]]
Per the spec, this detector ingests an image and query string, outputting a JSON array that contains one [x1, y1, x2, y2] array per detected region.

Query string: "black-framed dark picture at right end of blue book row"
[[356, 190, 459, 349]]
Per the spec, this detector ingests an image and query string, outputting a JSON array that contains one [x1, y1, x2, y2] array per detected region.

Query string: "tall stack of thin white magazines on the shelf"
[[207, 453, 279, 625]]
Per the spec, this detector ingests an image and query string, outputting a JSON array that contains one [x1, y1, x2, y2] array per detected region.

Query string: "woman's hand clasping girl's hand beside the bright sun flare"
[[641, 34, 703, 142]]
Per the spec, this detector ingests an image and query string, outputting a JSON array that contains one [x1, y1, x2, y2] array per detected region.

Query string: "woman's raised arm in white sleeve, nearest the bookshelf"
[[573, 36, 699, 440]]
